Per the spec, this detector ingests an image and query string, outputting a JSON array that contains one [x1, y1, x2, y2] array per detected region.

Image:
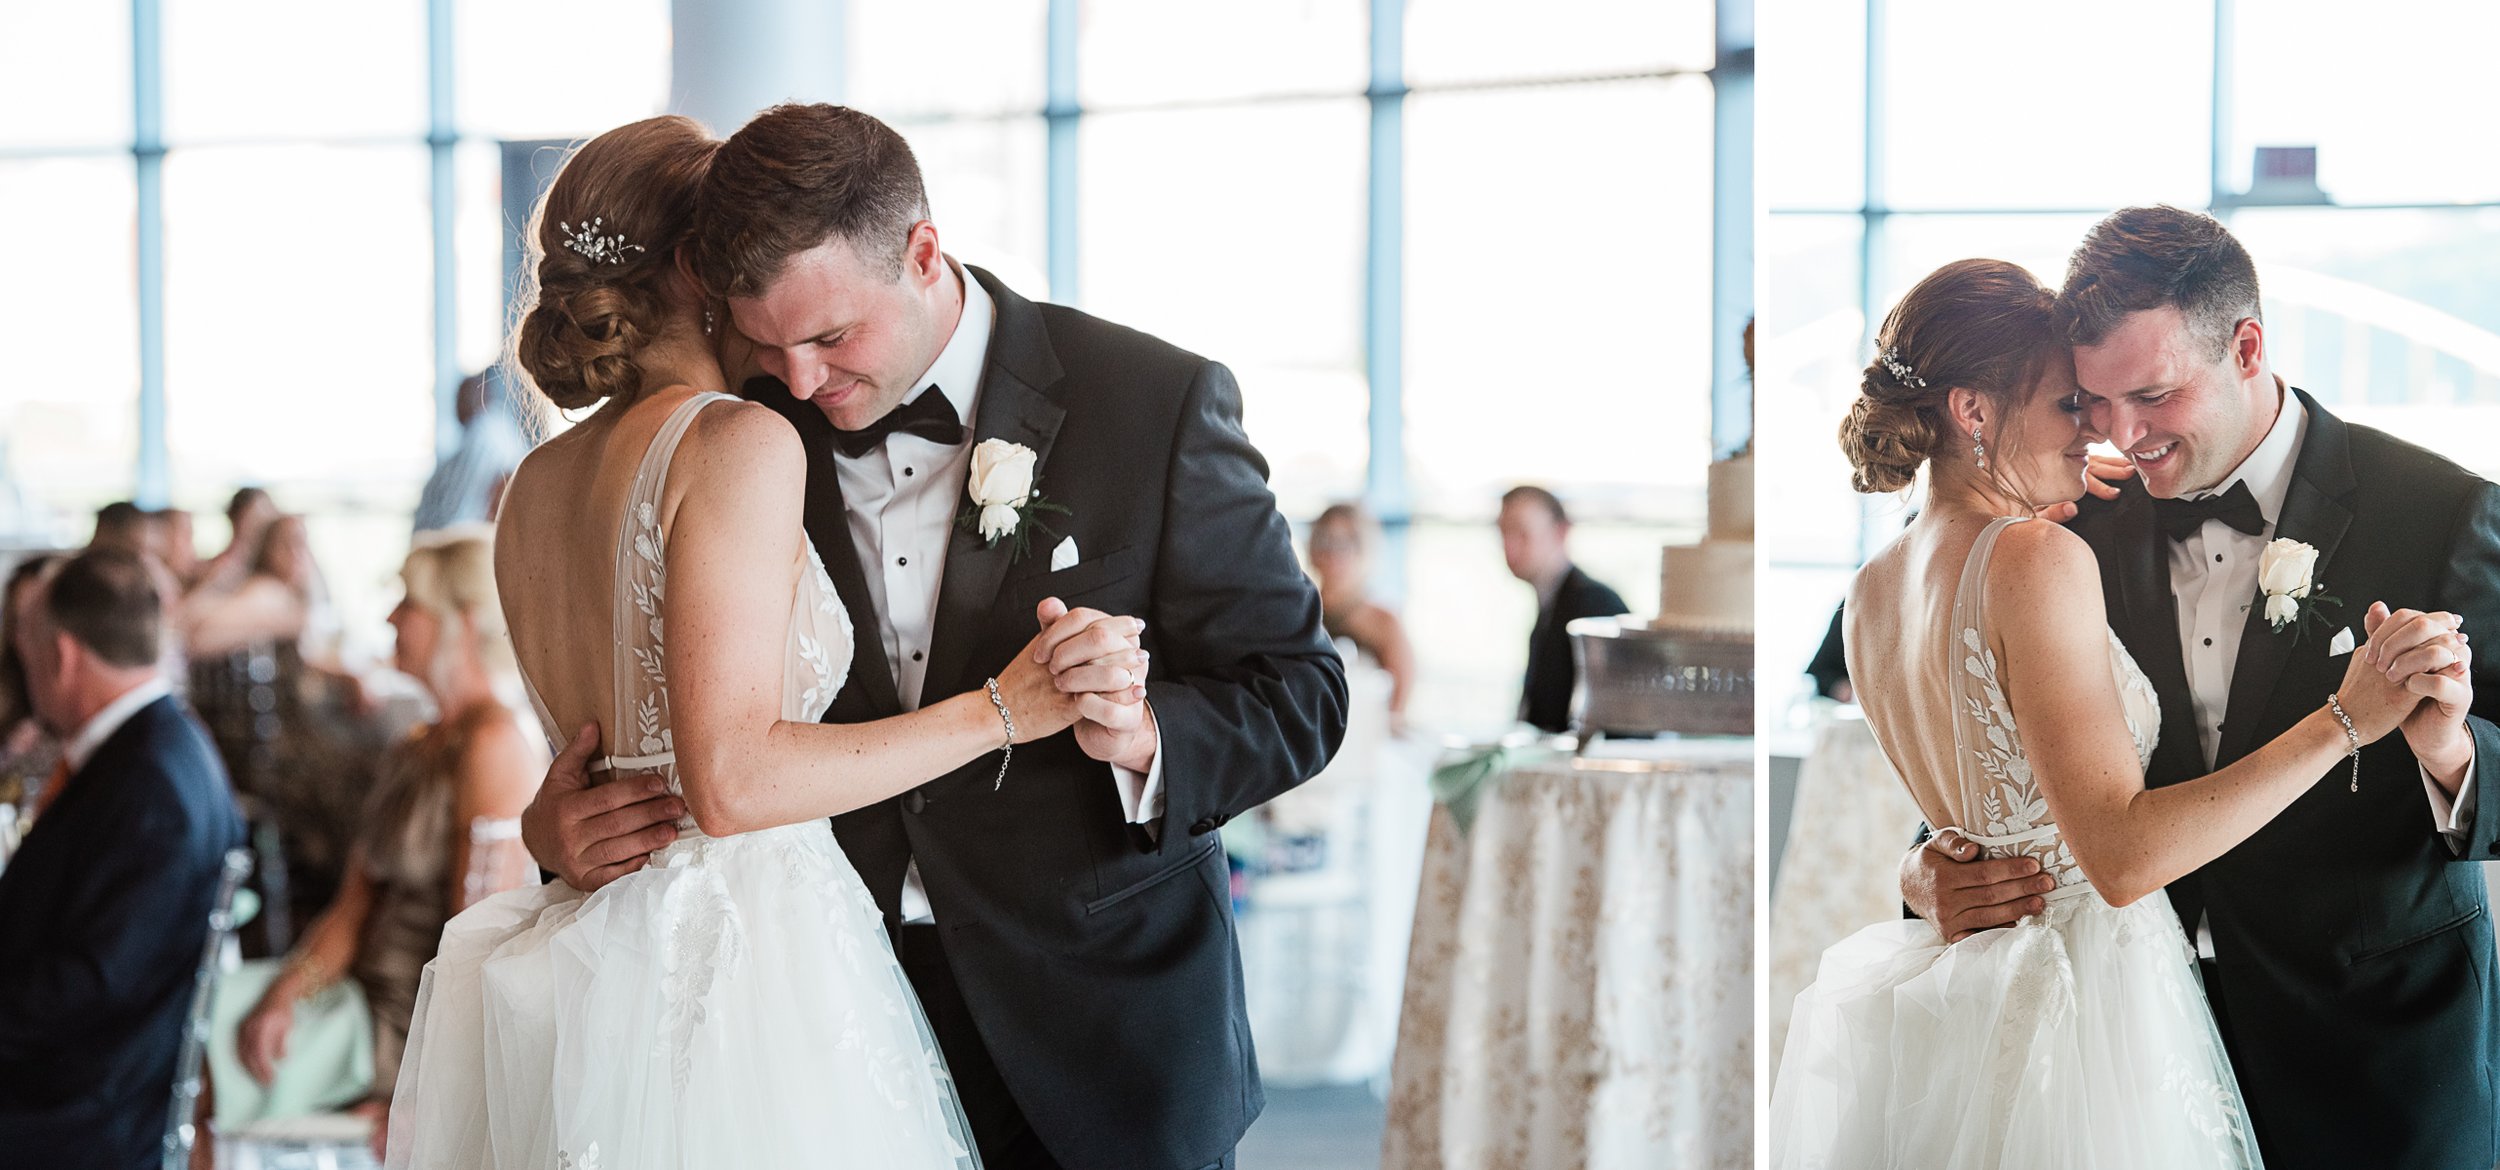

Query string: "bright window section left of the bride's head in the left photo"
[[0, 0, 668, 653]]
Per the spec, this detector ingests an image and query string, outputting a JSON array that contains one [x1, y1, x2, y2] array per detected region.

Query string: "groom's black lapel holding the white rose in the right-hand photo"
[[2215, 390, 2360, 765]]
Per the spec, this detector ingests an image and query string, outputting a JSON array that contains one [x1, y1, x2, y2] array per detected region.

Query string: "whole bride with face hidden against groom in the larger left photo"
[[388, 118, 1143, 1170]]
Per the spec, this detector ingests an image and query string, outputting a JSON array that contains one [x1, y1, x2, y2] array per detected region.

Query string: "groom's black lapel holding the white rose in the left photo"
[[920, 265, 1068, 700]]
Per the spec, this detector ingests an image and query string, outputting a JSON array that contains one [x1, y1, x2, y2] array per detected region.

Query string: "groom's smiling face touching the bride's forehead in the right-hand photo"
[[2075, 305, 2275, 500]]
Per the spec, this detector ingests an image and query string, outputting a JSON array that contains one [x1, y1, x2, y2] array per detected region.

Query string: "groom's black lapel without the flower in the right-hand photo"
[[2103, 483, 2205, 785]]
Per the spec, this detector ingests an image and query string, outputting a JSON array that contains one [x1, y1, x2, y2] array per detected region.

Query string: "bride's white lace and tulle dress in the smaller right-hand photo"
[[1770, 520, 2258, 1170]]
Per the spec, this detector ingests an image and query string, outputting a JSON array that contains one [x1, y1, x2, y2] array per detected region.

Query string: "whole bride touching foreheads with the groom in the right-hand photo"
[[1770, 260, 2450, 1170]]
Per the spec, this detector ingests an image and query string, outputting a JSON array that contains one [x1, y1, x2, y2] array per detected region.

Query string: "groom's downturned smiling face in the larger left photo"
[[730, 220, 963, 430]]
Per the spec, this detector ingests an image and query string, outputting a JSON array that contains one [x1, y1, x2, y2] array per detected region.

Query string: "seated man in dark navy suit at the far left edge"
[[0, 550, 243, 1170]]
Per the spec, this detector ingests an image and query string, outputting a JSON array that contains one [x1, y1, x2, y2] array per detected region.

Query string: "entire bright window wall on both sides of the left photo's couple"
[[0, 0, 1753, 730]]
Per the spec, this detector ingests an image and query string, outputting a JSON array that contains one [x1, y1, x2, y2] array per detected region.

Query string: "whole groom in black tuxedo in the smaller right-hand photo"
[[1903, 208, 2500, 1170]]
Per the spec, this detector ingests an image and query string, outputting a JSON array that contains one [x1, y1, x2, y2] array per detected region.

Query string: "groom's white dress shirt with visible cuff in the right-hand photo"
[[2170, 383, 2473, 958]]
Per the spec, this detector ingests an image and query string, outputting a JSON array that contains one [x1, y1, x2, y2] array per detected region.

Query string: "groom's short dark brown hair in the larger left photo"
[[695, 103, 930, 298]]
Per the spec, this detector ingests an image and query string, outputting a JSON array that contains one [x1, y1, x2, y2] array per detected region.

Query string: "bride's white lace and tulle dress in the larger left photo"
[[388, 393, 978, 1170]]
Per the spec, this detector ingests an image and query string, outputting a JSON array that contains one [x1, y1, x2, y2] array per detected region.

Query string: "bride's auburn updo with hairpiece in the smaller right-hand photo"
[[1840, 260, 2058, 493]]
